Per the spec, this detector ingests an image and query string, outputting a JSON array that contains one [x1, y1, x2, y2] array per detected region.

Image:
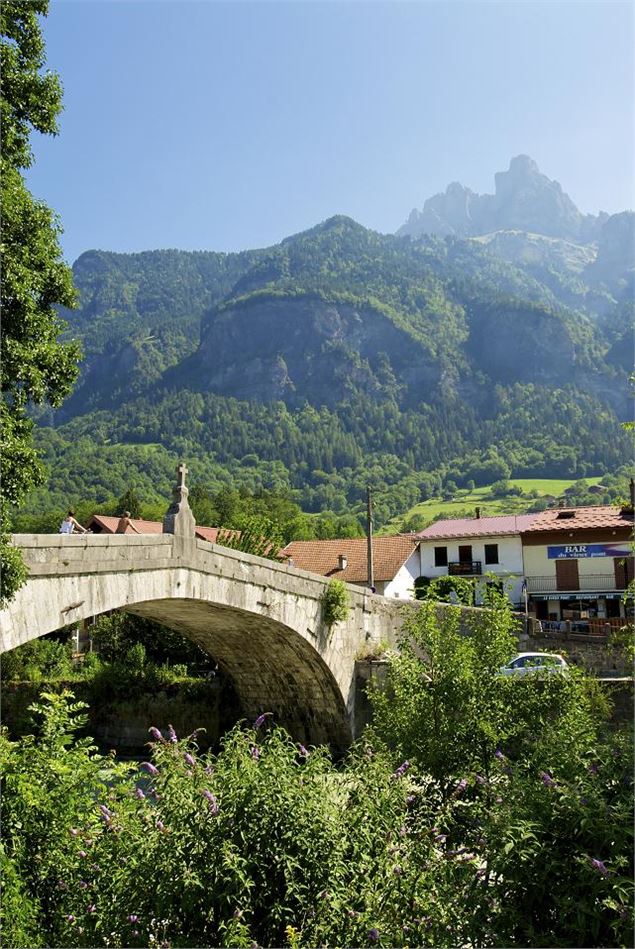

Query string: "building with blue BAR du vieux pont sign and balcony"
[[521, 505, 633, 633]]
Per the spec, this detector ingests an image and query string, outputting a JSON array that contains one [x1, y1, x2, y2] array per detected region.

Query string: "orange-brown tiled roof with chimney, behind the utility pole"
[[282, 534, 417, 583]]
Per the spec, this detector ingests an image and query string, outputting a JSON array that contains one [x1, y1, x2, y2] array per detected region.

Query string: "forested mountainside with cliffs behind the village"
[[24, 206, 632, 521]]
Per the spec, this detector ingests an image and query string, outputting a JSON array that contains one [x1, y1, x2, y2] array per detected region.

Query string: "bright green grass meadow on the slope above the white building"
[[377, 477, 602, 534]]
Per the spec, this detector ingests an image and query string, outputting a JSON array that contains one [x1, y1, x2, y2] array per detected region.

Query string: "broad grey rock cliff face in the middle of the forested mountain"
[[178, 295, 440, 405]]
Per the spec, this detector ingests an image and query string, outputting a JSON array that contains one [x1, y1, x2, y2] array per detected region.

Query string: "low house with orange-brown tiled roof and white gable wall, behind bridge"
[[282, 534, 419, 599]]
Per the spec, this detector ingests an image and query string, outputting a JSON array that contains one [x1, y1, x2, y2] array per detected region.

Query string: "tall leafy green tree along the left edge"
[[0, 0, 80, 600]]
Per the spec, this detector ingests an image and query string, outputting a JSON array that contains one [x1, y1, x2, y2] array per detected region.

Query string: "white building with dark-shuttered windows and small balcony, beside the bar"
[[414, 510, 537, 605]]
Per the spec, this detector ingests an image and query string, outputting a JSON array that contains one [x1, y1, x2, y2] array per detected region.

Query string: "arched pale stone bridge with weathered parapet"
[[0, 534, 403, 748]]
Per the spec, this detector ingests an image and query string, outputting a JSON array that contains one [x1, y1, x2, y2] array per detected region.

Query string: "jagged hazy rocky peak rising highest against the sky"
[[397, 155, 607, 243]]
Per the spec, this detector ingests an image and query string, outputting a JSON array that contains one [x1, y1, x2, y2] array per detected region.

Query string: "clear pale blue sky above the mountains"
[[29, 0, 635, 261]]
